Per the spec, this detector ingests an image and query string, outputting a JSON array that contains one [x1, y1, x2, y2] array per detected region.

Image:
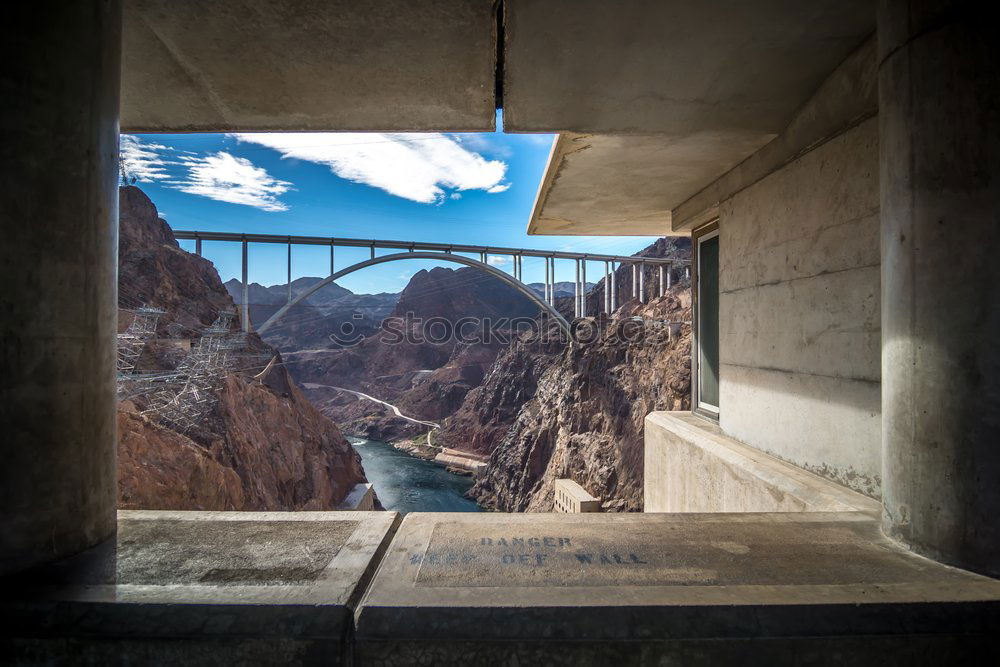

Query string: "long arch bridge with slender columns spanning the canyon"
[[174, 231, 689, 333]]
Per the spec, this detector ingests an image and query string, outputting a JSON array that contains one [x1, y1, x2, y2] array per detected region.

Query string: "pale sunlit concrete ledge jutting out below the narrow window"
[[643, 412, 881, 517]]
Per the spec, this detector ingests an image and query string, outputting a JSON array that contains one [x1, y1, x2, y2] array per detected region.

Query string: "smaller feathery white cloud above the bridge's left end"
[[168, 151, 292, 211]]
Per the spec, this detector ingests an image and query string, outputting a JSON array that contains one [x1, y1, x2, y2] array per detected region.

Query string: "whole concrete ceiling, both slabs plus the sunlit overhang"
[[122, 0, 875, 234]]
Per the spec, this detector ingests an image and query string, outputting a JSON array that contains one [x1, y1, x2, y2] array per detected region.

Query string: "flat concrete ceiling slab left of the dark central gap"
[[121, 0, 496, 132]]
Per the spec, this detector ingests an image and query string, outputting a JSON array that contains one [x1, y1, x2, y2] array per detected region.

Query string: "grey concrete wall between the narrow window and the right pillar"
[[719, 118, 881, 497]]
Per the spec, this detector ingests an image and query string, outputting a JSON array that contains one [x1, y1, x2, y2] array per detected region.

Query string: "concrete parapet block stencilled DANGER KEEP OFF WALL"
[[356, 512, 1000, 665]]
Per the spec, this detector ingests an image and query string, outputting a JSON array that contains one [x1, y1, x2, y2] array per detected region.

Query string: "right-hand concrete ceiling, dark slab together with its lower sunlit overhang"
[[503, 0, 875, 234]]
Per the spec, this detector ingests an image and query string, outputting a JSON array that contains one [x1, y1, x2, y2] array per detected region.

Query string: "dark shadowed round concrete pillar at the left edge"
[[0, 0, 121, 574]]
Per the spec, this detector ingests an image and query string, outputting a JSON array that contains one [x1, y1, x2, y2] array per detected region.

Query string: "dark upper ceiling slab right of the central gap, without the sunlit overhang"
[[504, 0, 875, 139]]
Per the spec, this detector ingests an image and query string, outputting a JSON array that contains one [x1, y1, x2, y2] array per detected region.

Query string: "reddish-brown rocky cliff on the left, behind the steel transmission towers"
[[118, 187, 364, 510]]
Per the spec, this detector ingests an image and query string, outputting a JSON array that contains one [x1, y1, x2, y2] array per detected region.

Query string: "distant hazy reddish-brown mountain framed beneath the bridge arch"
[[276, 267, 538, 440]]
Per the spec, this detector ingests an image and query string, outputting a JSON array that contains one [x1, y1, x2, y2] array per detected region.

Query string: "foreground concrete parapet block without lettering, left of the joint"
[[0, 511, 399, 664]]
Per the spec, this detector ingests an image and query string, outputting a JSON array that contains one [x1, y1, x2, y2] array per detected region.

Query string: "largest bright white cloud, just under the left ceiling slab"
[[233, 132, 507, 204]]
